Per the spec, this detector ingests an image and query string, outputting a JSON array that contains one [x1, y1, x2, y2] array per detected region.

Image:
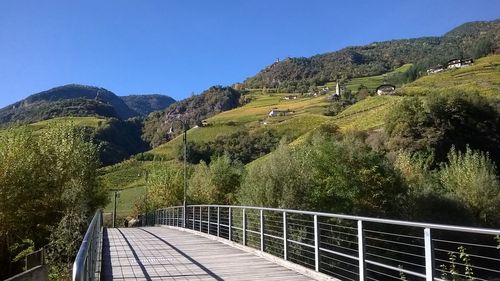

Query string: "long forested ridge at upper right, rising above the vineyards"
[[244, 20, 500, 92]]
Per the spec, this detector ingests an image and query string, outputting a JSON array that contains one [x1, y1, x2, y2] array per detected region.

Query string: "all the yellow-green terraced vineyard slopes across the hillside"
[[97, 55, 500, 215]]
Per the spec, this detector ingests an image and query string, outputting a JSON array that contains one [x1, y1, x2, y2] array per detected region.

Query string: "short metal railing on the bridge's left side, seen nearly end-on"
[[73, 210, 102, 281]]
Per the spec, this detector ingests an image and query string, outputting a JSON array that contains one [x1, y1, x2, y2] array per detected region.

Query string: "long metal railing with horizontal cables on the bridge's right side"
[[149, 205, 500, 281]]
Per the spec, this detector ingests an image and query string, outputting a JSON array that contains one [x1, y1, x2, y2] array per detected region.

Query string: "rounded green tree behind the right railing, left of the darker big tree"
[[305, 132, 406, 217]]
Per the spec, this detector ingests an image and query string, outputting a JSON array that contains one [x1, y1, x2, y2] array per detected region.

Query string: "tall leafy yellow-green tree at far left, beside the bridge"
[[0, 125, 107, 277]]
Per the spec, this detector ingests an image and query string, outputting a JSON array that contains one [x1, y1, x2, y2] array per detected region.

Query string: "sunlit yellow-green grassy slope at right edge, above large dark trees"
[[399, 55, 500, 98]]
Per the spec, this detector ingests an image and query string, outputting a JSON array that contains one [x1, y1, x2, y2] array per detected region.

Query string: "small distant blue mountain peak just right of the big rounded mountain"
[[120, 95, 175, 116]]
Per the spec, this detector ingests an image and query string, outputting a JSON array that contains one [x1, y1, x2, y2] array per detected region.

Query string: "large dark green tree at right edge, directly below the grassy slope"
[[385, 92, 500, 166]]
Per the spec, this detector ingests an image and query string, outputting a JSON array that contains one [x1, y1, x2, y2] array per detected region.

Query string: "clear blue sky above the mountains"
[[0, 0, 500, 108]]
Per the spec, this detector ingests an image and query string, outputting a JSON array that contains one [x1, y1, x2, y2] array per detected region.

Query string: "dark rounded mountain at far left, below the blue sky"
[[0, 84, 139, 124]]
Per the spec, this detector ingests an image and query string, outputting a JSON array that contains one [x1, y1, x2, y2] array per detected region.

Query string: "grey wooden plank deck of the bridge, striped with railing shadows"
[[102, 227, 311, 281]]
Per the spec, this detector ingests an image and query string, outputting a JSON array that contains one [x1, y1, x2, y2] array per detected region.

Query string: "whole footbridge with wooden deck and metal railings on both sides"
[[73, 205, 500, 281]]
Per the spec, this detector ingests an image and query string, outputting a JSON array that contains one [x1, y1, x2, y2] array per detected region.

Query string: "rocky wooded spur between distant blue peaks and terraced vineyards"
[[143, 86, 242, 146]]
